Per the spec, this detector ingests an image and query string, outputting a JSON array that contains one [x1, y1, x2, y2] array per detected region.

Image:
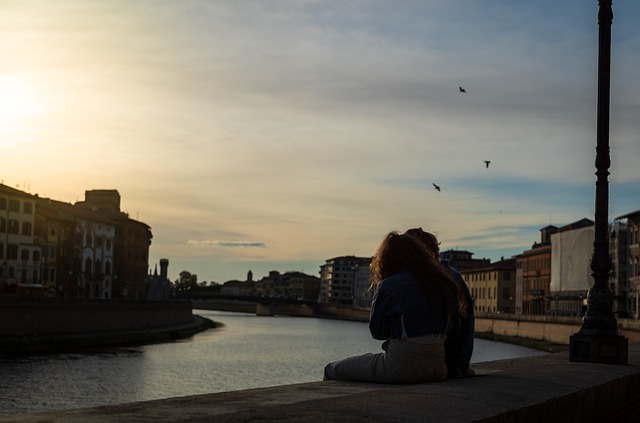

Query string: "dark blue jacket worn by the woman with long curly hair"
[[369, 272, 447, 340]]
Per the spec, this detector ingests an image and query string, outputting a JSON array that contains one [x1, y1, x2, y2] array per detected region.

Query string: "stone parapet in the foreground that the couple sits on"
[[0, 344, 640, 423]]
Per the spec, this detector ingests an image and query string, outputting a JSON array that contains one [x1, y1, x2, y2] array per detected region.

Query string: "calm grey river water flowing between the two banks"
[[0, 310, 544, 415]]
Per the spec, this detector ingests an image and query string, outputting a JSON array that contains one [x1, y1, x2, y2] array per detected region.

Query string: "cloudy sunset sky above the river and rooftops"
[[0, 0, 640, 283]]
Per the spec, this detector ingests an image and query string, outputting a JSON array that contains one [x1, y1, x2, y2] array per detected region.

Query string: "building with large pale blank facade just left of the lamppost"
[[550, 218, 595, 316]]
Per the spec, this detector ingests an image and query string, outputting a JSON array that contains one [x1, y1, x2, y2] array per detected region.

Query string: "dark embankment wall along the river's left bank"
[[0, 299, 215, 357]]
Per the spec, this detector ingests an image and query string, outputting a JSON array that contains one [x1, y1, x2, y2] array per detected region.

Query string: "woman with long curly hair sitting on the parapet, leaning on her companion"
[[324, 232, 467, 383]]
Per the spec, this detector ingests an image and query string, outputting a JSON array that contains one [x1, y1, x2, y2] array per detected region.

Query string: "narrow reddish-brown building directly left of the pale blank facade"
[[516, 225, 558, 314]]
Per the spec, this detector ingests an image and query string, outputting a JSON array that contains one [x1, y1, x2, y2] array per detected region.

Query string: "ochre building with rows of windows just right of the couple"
[[460, 258, 516, 313]]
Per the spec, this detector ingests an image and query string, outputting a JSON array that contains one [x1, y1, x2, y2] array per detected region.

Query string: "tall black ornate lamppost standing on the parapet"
[[569, 0, 629, 364]]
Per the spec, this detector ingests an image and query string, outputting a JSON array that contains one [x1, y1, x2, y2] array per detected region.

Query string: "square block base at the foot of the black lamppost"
[[569, 332, 629, 364]]
